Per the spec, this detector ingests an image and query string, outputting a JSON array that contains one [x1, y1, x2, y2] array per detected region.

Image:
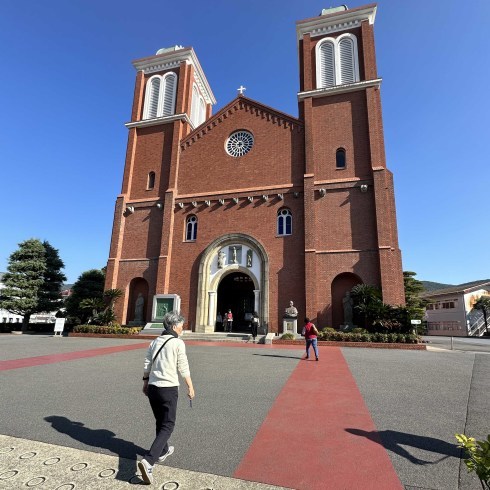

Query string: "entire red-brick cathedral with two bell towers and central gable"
[[106, 4, 404, 332]]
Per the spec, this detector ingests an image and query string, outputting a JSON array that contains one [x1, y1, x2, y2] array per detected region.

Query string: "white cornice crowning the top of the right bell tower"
[[296, 3, 377, 41]]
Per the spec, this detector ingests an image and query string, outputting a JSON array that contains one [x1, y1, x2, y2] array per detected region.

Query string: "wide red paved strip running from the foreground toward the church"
[[233, 347, 403, 490]]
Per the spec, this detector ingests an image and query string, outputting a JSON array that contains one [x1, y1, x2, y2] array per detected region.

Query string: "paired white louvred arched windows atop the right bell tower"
[[315, 33, 359, 88]]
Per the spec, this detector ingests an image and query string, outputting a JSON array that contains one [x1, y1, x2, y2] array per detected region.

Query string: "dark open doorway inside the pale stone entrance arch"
[[216, 272, 255, 332]]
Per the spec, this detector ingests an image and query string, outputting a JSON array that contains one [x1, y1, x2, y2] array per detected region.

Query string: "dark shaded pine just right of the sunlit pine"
[[38, 241, 66, 312]]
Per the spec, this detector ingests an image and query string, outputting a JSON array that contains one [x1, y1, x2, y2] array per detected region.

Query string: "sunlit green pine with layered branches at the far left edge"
[[0, 238, 46, 332]]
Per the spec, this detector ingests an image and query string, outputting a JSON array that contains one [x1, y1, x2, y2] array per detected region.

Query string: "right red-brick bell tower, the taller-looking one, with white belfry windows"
[[297, 4, 405, 328]]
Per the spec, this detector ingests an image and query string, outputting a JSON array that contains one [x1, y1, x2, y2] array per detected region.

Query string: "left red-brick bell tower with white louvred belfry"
[[105, 46, 216, 324]]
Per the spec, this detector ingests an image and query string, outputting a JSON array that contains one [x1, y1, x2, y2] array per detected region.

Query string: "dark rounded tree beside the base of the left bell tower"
[[65, 269, 105, 323]]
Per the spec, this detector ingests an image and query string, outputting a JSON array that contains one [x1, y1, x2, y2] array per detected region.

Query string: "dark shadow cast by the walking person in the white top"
[[44, 415, 146, 484]]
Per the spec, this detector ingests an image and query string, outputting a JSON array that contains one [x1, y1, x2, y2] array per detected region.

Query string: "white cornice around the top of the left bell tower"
[[133, 48, 216, 105]]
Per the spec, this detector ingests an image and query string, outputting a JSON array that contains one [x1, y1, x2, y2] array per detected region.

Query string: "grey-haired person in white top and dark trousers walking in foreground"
[[138, 311, 195, 485]]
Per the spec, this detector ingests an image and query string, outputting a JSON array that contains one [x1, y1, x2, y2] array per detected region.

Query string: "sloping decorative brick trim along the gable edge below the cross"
[[180, 95, 304, 150]]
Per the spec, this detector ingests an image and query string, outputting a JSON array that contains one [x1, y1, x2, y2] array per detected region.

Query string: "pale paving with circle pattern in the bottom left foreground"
[[0, 435, 285, 490]]
